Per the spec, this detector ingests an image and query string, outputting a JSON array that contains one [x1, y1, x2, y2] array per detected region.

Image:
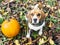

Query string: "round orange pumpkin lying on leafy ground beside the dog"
[[1, 19, 20, 37]]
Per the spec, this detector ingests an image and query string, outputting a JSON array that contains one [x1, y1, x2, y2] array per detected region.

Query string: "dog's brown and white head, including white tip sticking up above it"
[[26, 4, 46, 24]]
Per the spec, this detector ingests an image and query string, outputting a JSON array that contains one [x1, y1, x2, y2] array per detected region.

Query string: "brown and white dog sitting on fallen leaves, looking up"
[[26, 4, 47, 38]]
